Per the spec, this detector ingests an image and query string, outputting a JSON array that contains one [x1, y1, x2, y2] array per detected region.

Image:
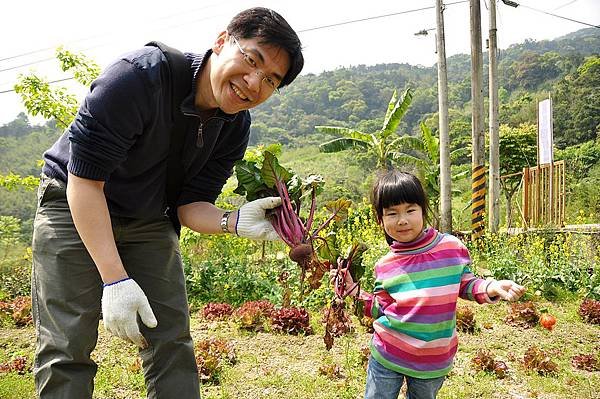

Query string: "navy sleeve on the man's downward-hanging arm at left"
[[67, 59, 152, 180]]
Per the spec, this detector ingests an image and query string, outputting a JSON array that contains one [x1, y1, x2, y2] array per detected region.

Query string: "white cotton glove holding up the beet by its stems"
[[235, 197, 281, 241]]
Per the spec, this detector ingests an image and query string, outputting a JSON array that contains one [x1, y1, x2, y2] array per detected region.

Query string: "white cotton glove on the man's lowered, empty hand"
[[102, 278, 158, 349]]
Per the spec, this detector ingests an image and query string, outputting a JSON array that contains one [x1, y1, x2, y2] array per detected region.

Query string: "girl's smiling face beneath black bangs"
[[382, 203, 425, 242]]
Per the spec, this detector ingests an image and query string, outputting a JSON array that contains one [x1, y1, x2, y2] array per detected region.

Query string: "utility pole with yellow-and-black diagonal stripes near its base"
[[469, 0, 485, 240]]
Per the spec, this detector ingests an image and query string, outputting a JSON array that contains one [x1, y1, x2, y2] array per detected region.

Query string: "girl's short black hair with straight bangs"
[[371, 169, 431, 244]]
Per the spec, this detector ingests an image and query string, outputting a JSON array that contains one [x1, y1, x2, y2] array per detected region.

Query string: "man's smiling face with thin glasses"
[[207, 32, 290, 114]]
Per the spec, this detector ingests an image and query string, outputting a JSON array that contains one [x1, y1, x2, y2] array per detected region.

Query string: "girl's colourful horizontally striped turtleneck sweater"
[[363, 228, 495, 379]]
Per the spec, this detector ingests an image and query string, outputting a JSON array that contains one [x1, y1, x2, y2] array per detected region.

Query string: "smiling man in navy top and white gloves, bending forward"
[[32, 8, 304, 399]]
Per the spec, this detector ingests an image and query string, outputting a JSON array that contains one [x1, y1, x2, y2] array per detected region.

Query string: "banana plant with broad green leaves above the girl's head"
[[315, 89, 412, 169]]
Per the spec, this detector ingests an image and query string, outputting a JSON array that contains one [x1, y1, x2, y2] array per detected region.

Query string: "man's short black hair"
[[227, 7, 304, 87]]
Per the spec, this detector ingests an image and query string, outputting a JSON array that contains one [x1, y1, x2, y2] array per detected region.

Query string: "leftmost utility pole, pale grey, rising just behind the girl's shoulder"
[[436, 0, 452, 233]]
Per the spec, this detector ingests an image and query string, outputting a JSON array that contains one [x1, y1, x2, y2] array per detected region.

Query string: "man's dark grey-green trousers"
[[31, 178, 200, 399]]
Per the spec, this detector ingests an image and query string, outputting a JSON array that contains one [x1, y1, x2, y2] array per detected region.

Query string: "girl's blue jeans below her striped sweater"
[[365, 356, 446, 399]]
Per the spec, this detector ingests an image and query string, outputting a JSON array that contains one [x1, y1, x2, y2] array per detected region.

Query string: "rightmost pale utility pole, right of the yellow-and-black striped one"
[[488, 0, 500, 233]]
